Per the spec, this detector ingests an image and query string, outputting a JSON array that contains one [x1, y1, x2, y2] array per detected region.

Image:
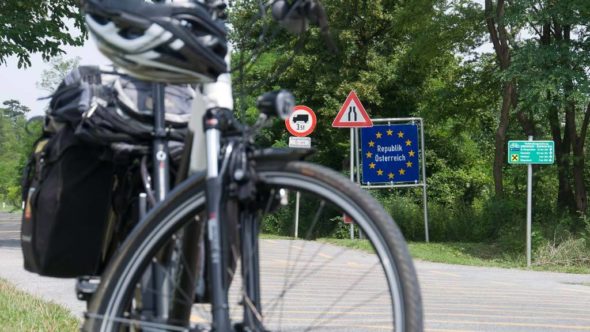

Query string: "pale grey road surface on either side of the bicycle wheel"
[[0, 213, 590, 331]]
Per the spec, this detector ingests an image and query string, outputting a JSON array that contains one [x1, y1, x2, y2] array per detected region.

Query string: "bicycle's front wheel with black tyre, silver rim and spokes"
[[84, 162, 422, 331]]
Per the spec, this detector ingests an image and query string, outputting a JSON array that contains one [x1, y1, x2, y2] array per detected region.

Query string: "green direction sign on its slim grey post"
[[508, 136, 555, 267]]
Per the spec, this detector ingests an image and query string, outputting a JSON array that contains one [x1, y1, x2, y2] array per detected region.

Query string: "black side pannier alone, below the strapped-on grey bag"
[[21, 125, 113, 278]]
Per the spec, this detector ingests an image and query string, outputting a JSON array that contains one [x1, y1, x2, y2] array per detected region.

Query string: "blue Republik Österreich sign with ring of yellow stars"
[[360, 124, 420, 184]]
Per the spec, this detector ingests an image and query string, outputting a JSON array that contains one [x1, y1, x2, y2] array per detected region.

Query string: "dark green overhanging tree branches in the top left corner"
[[0, 0, 86, 68]]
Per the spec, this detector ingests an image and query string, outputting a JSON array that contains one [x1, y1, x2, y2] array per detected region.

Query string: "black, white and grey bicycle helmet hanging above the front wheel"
[[83, 0, 227, 83]]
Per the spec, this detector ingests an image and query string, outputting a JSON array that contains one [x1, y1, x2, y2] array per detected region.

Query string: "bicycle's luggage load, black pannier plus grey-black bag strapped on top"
[[21, 66, 194, 278]]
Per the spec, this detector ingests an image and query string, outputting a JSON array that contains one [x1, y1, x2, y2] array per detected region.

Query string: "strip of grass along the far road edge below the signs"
[[321, 238, 590, 274]]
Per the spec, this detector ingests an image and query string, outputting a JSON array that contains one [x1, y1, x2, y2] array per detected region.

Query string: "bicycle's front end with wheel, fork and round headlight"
[[83, 0, 422, 331]]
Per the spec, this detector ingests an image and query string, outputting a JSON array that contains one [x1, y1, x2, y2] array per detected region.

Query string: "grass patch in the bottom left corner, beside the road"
[[0, 279, 80, 332]]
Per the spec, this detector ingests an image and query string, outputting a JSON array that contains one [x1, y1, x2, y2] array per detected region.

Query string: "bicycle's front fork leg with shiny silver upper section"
[[204, 109, 232, 332]]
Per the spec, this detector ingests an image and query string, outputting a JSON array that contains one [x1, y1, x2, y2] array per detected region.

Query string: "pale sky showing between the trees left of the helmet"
[[0, 39, 109, 116]]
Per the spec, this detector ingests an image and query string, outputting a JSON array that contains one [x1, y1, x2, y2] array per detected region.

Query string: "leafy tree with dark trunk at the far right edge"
[[509, 0, 590, 218]]
